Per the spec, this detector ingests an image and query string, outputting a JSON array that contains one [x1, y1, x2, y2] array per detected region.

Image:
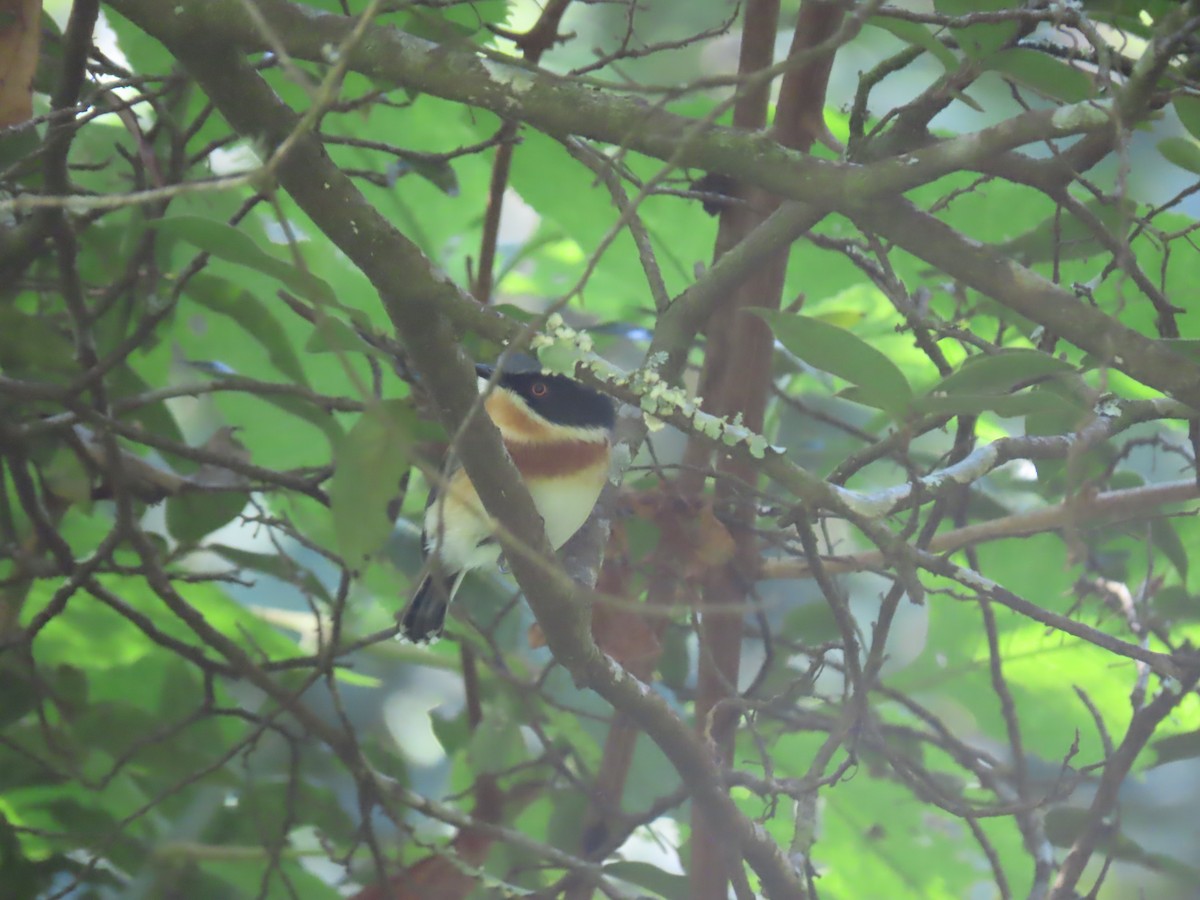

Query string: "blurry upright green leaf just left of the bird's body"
[[329, 400, 416, 566]]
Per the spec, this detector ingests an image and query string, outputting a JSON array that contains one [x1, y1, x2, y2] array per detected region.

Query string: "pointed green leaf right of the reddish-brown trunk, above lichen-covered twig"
[[750, 310, 912, 419]]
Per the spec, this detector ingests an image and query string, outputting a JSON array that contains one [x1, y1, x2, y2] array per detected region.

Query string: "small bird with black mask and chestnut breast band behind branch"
[[400, 361, 616, 643]]
